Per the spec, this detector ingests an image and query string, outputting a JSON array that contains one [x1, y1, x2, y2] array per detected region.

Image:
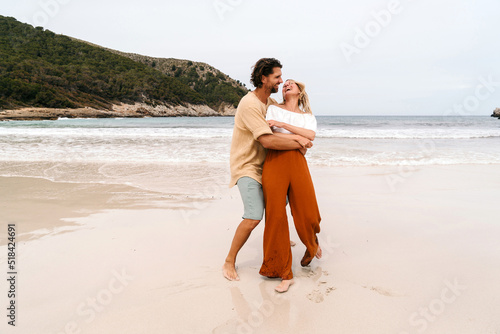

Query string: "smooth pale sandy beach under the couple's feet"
[[0, 165, 500, 334]]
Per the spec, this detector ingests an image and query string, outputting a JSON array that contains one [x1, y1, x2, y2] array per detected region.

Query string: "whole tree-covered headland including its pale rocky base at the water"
[[0, 15, 248, 120]]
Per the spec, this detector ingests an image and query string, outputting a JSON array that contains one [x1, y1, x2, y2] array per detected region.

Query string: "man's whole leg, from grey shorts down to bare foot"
[[222, 176, 264, 281]]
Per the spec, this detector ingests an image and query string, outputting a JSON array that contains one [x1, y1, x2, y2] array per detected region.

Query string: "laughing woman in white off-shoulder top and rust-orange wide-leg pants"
[[260, 80, 321, 292]]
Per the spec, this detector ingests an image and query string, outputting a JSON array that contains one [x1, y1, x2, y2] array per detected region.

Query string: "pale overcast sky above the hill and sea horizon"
[[0, 0, 500, 115]]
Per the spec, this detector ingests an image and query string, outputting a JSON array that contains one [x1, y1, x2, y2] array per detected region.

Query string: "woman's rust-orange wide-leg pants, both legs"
[[260, 150, 321, 279]]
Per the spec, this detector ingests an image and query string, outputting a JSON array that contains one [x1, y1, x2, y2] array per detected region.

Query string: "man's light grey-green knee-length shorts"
[[236, 176, 264, 220]]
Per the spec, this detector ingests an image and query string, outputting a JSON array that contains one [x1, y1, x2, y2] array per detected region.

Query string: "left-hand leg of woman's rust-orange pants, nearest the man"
[[260, 150, 293, 280]]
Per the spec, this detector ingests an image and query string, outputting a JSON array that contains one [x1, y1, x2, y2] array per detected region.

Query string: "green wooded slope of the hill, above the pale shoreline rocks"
[[0, 16, 247, 109]]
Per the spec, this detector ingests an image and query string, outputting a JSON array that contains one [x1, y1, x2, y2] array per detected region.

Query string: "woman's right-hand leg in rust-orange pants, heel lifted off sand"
[[288, 151, 321, 266]]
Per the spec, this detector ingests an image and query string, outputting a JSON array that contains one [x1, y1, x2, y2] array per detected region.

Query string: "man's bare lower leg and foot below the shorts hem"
[[222, 219, 260, 281]]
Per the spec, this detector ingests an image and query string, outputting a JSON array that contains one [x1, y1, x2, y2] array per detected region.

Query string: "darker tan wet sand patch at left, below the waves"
[[0, 176, 170, 245]]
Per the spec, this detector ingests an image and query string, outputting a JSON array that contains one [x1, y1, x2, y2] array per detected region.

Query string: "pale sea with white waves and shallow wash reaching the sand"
[[0, 116, 500, 193]]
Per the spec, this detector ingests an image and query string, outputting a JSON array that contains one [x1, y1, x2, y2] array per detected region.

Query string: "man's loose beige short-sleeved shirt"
[[229, 92, 276, 187]]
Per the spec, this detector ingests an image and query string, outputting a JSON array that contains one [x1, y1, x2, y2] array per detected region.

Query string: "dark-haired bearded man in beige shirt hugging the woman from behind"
[[222, 58, 312, 281]]
